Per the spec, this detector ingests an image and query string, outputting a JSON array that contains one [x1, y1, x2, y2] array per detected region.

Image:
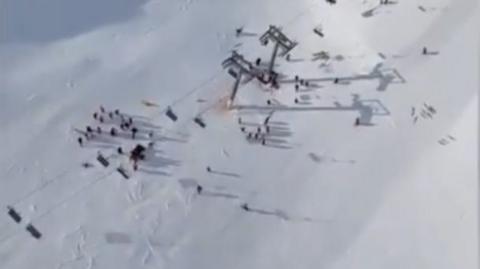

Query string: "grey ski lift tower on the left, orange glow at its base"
[[222, 51, 256, 103]]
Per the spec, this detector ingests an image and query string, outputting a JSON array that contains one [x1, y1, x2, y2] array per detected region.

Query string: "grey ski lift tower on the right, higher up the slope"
[[260, 25, 297, 74]]
